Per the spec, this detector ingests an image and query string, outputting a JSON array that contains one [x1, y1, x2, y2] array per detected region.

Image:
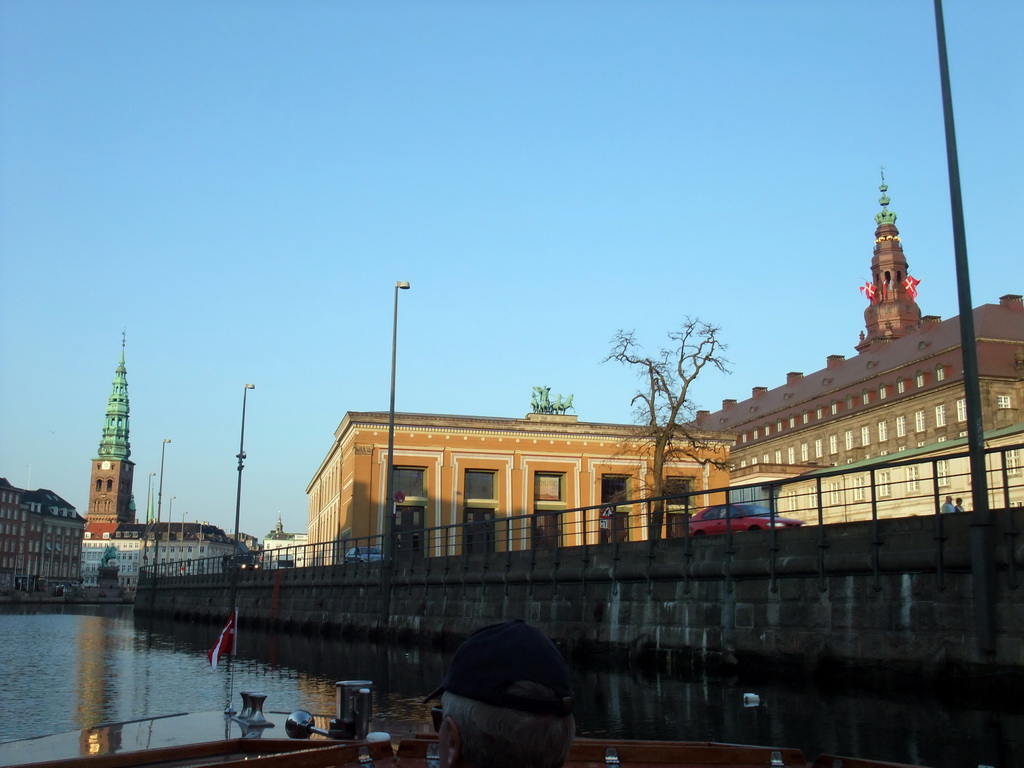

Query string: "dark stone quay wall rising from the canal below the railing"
[[135, 508, 1024, 677]]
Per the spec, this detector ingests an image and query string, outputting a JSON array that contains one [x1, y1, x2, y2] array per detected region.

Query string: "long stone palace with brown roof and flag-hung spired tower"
[[696, 176, 1024, 495]]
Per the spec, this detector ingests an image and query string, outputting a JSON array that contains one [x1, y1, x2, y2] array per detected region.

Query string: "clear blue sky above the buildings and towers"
[[0, 0, 1024, 536]]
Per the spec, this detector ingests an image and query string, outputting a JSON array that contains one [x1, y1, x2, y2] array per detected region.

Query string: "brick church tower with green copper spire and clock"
[[87, 338, 135, 523]]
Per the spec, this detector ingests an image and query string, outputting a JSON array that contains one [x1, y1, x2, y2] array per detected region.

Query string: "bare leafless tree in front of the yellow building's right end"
[[604, 317, 729, 539]]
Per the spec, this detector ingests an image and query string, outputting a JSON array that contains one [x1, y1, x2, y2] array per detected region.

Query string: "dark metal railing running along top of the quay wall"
[[140, 443, 1024, 587]]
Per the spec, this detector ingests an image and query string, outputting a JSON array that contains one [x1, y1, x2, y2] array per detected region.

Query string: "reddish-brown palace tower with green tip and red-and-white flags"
[[856, 176, 921, 352]]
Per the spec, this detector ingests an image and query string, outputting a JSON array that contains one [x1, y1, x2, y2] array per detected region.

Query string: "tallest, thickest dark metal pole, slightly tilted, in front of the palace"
[[935, 0, 995, 653]]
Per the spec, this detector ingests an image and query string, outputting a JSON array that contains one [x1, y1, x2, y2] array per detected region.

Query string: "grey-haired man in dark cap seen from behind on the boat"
[[427, 620, 575, 768]]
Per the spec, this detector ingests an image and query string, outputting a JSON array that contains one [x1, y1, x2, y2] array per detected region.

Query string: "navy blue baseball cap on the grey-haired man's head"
[[426, 618, 572, 716]]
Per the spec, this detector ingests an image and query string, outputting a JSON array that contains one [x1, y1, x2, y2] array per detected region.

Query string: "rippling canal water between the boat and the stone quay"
[[0, 606, 1024, 768]]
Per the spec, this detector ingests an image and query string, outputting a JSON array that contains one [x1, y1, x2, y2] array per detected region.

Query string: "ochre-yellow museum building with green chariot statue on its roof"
[[306, 412, 733, 555]]
